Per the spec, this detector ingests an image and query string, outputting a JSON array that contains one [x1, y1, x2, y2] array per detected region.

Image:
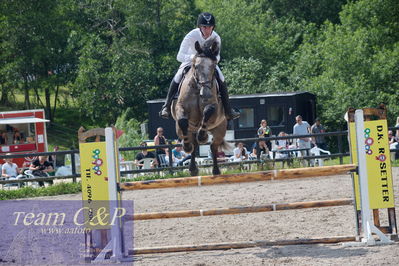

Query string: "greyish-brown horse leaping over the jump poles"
[[171, 41, 230, 176]]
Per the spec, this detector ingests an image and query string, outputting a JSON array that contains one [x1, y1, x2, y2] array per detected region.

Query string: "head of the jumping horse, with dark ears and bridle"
[[192, 42, 219, 99]]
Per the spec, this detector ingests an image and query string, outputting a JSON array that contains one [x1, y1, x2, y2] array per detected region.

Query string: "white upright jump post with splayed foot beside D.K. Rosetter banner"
[[355, 110, 392, 245]]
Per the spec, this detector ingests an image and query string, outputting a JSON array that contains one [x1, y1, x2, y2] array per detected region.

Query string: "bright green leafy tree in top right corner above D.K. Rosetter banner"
[[291, 0, 399, 128]]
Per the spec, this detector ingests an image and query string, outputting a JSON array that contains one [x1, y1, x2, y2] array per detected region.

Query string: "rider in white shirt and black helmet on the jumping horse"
[[159, 12, 240, 120]]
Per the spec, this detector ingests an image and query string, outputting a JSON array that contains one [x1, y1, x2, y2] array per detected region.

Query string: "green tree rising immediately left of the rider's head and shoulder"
[[126, 0, 199, 98]]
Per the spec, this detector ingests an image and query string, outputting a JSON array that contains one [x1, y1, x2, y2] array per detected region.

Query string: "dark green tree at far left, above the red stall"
[[0, 0, 74, 120]]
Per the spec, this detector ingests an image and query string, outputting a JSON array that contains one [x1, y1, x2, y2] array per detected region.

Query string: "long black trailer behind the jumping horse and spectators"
[[147, 92, 316, 139]]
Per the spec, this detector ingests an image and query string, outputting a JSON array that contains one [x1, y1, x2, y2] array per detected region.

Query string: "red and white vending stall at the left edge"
[[0, 109, 49, 167]]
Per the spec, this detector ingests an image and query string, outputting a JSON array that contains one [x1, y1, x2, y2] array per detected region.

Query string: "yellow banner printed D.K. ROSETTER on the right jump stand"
[[349, 120, 395, 210]]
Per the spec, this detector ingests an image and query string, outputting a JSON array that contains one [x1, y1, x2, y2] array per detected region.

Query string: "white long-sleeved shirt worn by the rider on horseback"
[[177, 28, 222, 68]]
